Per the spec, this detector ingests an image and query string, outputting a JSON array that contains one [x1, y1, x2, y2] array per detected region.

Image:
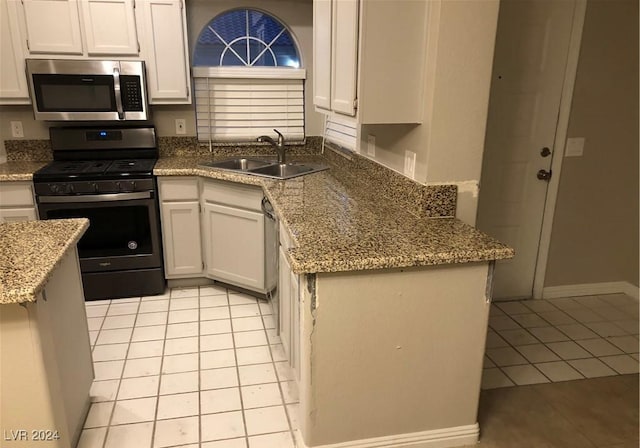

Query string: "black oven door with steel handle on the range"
[[38, 191, 162, 273]]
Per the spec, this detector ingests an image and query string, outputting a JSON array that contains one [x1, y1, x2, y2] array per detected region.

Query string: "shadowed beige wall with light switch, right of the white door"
[[545, 0, 638, 286]]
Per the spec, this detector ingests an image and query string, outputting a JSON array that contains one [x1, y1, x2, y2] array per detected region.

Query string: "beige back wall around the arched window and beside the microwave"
[[0, 0, 324, 143]]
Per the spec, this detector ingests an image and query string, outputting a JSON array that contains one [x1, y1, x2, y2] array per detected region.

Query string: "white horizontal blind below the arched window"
[[194, 76, 304, 142]]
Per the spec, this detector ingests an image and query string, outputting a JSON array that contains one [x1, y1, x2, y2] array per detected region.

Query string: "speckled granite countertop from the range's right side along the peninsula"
[[154, 156, 514, 273]]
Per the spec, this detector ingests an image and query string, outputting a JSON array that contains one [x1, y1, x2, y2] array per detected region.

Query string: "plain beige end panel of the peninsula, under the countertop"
[[299, 263, 490, 447]]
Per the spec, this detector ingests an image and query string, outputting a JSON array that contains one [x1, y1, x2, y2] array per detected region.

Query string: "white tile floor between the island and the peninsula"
[[78, 286, 298, 448]]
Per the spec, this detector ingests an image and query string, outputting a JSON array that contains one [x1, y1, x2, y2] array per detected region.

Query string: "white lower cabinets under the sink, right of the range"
[[158, 176, 277, 294]]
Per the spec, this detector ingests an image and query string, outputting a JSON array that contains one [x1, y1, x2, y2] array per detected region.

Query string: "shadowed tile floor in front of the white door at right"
[[482, 294, 639, 389]]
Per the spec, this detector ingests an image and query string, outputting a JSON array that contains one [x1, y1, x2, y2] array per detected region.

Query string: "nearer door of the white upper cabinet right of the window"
[[331, 0, 358, 116]]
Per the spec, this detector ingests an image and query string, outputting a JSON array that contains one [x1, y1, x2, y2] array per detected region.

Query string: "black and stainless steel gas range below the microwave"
[[33, 126, 165, 300]]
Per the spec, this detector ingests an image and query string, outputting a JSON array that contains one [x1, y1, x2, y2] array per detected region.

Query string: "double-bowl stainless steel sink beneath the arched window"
[[200, 157, 329, 179]]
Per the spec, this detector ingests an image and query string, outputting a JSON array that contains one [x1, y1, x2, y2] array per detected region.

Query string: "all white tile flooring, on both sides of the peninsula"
[[78, 286, 639, 448]]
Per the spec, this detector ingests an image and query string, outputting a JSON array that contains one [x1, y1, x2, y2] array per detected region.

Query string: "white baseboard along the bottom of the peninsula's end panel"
[[295, 423, 480, 448]]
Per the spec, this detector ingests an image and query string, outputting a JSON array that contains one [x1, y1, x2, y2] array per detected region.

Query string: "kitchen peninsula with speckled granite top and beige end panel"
[[154, 146, 513, 448]]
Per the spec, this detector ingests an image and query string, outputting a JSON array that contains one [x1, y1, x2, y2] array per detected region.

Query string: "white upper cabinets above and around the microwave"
[[0, 0, 191, 104]]
